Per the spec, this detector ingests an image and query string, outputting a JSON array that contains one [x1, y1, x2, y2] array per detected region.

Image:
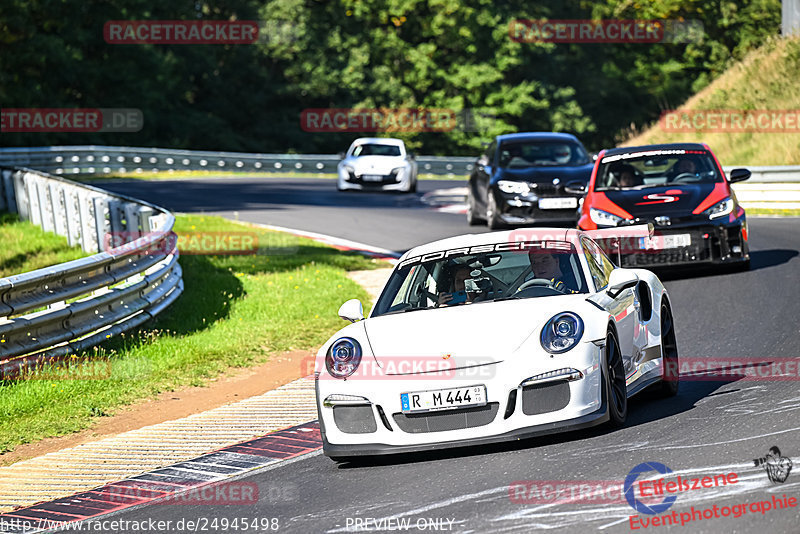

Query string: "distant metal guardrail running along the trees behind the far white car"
[[0, 146, 475, 175]]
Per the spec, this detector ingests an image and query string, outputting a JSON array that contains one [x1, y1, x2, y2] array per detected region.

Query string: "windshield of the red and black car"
[[595, 150, 723, 191]]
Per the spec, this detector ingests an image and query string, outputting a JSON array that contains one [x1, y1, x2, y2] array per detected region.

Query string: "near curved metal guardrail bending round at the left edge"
[[0, 167, 183, 378]]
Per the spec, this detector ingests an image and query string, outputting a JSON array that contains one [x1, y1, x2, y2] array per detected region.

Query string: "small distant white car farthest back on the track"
[[336, 137, 417, 193]]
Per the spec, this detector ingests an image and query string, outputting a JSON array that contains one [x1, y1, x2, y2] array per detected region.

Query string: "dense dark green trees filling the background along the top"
[[0, 0, 780, 154]]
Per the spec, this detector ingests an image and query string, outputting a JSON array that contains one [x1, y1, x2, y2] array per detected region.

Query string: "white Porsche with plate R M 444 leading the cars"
[[315, 226, 678, 459]]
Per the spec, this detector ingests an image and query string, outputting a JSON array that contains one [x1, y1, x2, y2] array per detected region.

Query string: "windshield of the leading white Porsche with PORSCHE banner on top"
[[372, 241, 588, 317]]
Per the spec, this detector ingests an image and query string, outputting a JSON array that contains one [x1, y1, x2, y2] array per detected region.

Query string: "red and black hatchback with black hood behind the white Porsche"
[[578, 143, 750, 269]]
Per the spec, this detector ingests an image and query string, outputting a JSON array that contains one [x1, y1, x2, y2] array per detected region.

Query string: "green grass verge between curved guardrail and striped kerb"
[[0, 215, 385, 461]]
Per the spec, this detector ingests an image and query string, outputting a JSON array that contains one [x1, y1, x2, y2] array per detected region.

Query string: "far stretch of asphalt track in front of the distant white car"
[[98, 178, 487, 251]]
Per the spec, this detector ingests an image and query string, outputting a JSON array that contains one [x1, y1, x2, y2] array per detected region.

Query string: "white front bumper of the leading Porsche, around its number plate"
[[316, 341, 608, 457]]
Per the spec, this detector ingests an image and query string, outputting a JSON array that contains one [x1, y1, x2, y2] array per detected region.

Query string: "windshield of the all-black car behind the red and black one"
[[498, 141, 590, 169]]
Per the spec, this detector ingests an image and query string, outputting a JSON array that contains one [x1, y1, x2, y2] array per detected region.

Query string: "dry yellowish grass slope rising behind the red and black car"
[[624, 37, 800, 165]]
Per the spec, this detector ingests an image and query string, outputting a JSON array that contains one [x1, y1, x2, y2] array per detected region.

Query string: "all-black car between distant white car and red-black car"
[[467, 132, 592, 230]]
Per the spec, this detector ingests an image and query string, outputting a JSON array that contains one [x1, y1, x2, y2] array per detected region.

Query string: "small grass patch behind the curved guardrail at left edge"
[[0, 213, 88, 278]]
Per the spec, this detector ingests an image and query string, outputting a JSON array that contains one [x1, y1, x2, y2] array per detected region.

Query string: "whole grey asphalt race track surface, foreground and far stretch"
[[83, 178, 800, 533]]
